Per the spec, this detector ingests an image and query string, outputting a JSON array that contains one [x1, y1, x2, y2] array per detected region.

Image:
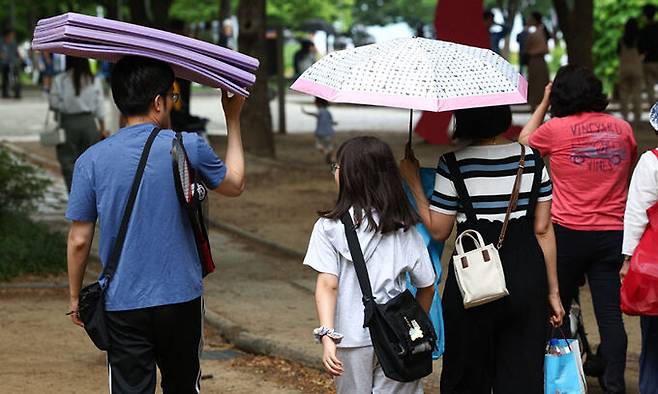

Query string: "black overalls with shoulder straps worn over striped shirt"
[[441, 150, 548, 394]]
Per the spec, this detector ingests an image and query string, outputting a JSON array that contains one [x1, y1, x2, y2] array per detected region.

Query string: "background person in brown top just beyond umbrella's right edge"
[[525, 12, 551, 111]]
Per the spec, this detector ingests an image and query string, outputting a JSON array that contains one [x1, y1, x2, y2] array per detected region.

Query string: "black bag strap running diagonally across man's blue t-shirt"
[[101, 127, 160, 287]]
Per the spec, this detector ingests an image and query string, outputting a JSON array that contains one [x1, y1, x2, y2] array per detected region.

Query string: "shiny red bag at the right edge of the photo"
[[621, 195, 658, 316]]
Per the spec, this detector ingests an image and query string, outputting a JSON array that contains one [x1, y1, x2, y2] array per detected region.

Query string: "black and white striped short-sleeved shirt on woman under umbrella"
[[430, 142, 553, 222]]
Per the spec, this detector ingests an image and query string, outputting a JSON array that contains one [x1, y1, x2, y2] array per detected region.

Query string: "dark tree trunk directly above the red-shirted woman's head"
[[553, 0, 594, 70]]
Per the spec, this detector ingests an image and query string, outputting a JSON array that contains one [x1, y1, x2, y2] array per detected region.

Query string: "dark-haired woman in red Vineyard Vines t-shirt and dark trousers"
[[519, 65, 637, 394]]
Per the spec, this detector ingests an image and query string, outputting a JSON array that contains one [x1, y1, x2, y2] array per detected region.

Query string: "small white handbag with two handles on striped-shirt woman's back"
[[452, 230, 509, 309]]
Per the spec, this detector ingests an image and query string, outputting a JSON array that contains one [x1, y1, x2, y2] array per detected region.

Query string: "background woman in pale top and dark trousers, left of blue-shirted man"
[[49, 56, 105, 192]]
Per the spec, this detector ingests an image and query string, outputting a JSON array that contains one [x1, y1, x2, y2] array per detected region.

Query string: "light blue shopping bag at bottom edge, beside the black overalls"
[[544, 339, 587, 394]]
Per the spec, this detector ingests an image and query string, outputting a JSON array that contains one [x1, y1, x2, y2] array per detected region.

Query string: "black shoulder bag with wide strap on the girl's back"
[[341, 212, 436, 382]]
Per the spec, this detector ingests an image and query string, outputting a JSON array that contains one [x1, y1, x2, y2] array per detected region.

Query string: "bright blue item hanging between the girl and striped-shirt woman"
[[405, 168, 445, 360]]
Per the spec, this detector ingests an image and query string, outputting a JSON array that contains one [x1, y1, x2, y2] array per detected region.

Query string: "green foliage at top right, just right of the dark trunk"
[[592, 0, 658, 92]]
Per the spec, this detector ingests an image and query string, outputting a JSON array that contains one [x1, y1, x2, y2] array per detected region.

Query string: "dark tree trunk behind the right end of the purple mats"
[[237, 0, 274, 157]]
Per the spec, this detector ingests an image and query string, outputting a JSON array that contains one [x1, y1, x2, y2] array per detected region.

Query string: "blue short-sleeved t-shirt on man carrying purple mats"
[[66, 123, 226, 311]]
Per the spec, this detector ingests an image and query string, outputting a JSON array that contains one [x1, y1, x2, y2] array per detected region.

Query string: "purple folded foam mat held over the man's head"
[[32, 13, 259, 96]]
